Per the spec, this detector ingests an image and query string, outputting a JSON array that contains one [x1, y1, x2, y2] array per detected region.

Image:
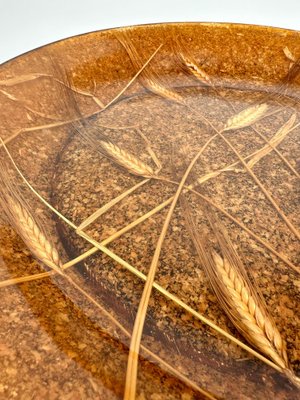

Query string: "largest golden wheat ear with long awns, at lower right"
[[185, 203, 289, 370]]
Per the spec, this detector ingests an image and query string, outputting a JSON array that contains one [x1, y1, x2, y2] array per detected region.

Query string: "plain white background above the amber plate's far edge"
[[0, 0, 300, 63]]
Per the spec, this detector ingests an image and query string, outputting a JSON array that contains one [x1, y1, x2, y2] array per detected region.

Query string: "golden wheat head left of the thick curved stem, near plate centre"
[[100, 140, 155, 178]]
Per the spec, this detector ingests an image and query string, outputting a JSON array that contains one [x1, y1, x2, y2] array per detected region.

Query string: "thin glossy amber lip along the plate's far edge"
[[0, 21, 300, 70]]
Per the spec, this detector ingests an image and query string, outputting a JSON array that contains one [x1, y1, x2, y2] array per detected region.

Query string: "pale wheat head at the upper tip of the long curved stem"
[[223, 103, 268, 131]]
